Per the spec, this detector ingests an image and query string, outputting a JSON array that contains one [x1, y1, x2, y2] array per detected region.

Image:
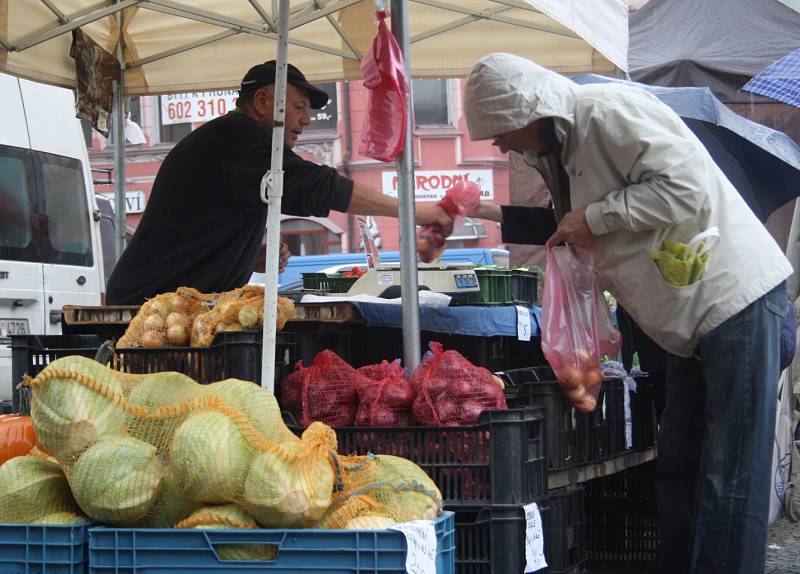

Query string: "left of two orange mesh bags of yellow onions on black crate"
[[117, 287, 208, 348]]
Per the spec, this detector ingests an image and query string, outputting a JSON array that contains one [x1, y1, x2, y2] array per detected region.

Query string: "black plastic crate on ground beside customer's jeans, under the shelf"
[[585, 462, 661, 572]]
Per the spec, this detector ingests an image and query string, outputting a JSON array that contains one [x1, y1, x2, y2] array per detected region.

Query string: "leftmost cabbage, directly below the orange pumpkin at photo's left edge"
[[0, 456, 79, 524]]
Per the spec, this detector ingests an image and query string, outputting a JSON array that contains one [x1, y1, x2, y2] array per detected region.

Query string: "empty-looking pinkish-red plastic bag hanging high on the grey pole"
[[358, 12, 408, 162]]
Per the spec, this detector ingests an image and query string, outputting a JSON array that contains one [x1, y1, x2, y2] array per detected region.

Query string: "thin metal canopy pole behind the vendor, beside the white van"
[[109, 0, 128, 262]]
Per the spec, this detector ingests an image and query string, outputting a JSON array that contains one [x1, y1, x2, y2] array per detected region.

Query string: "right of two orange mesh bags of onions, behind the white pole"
[[191, 285, 294, 347]]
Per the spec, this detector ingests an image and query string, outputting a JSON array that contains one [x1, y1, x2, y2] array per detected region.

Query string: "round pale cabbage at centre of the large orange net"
[[169, 411, 253, 503]]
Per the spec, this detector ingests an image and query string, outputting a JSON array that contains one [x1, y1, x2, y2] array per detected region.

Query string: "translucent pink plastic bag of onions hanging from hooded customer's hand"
[[542, 247, 622, 412]]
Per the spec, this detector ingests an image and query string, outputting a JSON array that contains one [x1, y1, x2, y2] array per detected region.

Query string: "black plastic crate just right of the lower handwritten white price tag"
[[540, 486, 586, 574]]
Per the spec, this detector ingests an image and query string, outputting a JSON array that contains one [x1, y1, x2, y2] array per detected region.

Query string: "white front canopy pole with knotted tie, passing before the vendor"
[[261, 0, 289, 394]]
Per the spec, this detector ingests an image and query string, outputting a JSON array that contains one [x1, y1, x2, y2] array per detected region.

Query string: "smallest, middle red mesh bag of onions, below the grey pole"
[[356, 359, 416, 427]]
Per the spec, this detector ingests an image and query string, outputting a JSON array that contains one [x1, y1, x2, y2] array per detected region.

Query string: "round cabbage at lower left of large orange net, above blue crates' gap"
[[70, 436, 164, 526]]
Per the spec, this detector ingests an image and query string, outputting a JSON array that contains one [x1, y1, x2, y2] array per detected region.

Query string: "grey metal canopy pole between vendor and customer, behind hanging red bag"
[[391, 0, 422, 372]]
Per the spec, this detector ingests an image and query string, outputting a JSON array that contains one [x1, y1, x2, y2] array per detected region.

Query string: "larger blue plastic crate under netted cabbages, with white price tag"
[[89, 512, 455, 574]]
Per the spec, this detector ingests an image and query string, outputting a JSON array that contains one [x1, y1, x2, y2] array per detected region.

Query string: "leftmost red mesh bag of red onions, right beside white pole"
[[281, 349, 360, 427]]
